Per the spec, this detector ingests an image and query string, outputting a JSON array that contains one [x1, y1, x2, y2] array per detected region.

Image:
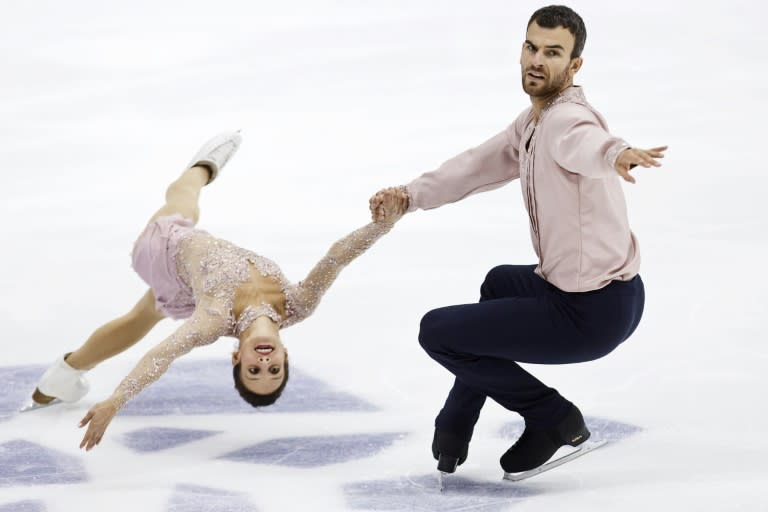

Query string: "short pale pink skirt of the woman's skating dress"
[[131, 214, 195, 320]]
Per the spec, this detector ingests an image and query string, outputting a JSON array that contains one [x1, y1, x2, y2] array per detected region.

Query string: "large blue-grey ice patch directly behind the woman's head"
[[121, 360, 377, 416]]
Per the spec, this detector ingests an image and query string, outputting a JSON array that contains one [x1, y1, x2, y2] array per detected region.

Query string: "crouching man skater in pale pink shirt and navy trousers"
[[370, 6, 666, 473]]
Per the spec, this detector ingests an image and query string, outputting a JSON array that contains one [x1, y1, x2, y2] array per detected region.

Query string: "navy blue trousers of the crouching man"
[[419, 265, 645, 441]]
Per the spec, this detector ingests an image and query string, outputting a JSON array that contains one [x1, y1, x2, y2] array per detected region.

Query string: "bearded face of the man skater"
[[520, 21, 581, 98]]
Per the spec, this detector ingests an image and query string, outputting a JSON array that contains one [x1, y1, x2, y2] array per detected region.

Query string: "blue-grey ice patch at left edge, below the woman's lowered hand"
[[0, 440, 88, 487]]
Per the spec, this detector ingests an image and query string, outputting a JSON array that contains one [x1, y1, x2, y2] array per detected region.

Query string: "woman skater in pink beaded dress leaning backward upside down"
[[27, 133, 404, 450]]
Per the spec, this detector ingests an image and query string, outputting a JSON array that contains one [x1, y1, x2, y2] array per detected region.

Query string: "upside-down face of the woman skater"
[[232, 336, 288, 395]]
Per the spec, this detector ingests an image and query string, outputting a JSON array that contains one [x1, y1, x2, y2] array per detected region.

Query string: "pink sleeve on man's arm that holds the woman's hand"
[[406, 115, 523, 211]]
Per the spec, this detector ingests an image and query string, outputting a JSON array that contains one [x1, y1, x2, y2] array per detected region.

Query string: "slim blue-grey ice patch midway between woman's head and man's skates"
[[219, 433, 405, 468]]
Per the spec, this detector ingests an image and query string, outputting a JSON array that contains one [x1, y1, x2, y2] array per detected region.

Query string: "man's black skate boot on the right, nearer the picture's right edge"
[[499, 405, 590, 473]]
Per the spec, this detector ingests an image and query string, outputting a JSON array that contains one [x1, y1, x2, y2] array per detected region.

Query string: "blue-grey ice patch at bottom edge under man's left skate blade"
[[344, 474, 541, 512]]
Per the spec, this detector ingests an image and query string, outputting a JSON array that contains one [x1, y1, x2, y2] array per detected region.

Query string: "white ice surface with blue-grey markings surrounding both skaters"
[[0, 0, 768, 512]]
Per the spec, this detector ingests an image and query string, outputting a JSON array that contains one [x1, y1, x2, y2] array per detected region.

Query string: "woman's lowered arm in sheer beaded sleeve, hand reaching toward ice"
[[80, 305, 230, 450]]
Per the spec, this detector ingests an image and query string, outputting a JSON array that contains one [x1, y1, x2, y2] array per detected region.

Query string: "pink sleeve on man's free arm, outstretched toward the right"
[[542, 105, 629, 178]]
